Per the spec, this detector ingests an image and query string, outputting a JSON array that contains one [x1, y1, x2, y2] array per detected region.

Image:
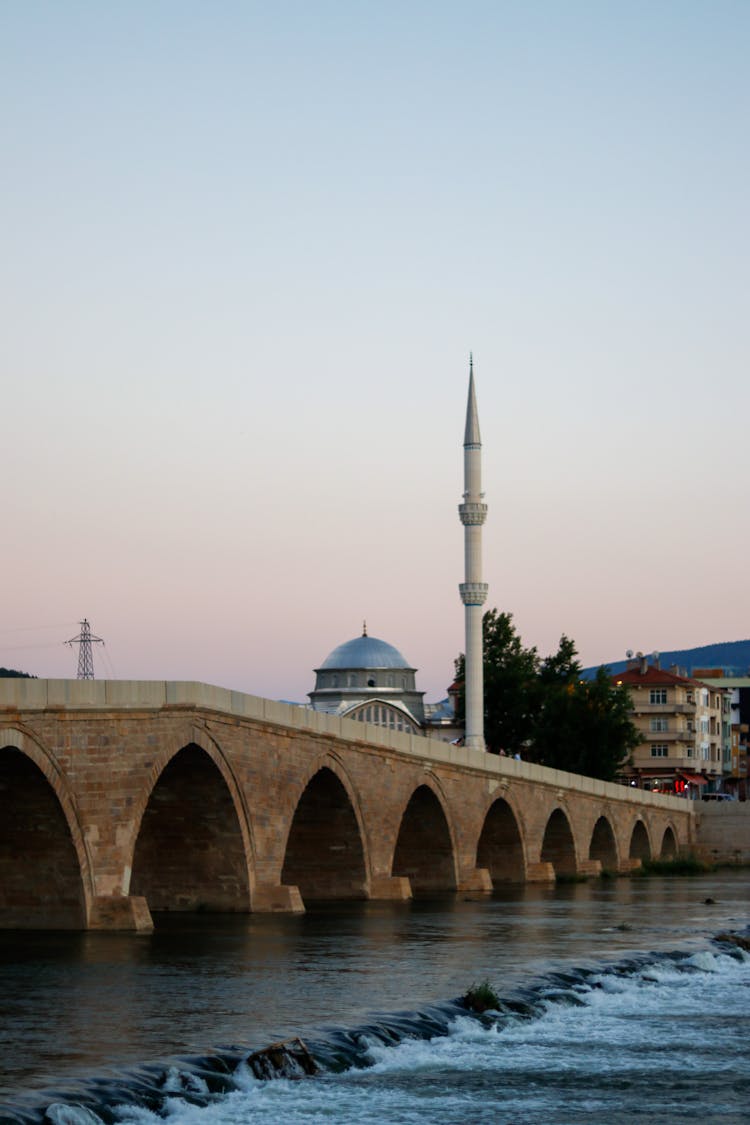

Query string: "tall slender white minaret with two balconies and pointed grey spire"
[[459, 356, 487, 750]]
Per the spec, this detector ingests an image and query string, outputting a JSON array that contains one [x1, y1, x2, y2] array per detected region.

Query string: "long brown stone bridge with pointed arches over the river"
[[0, 678, 695, 929]]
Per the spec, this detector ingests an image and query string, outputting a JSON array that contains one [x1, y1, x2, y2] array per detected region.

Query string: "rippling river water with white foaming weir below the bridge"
[[0, 872, 750, 1125]]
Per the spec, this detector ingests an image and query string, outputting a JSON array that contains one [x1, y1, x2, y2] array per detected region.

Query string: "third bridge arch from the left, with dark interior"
[[281, 754, 370, 905]]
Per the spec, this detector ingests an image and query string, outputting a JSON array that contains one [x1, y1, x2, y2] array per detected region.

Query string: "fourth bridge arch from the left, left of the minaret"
[[391, 774, 458, 894]]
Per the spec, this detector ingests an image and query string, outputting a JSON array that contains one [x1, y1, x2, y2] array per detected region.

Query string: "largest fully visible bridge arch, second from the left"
[[130, 730, 254, 912]]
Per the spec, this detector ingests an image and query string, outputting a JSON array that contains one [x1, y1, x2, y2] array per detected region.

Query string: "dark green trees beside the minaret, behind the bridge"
[[455, 610, 640, 781]]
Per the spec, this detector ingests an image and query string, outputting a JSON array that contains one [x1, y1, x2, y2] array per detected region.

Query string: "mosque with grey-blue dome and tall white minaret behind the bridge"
[[308, 359, 487, 749]]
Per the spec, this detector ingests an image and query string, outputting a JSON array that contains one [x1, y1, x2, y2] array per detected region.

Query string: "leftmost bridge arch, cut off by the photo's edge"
[[0, 728, 94, 929]]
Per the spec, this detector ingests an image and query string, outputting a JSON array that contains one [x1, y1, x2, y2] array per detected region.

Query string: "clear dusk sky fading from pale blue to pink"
[[0, 0, 750, 700]]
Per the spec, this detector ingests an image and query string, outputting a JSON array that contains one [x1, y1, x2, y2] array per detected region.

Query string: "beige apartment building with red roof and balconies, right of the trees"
[[613, 654, 731, 799]]
